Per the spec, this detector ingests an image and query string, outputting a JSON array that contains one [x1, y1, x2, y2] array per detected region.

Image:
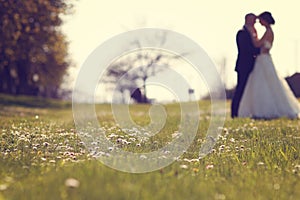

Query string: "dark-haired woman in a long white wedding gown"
[[238, 12, 300, 119]]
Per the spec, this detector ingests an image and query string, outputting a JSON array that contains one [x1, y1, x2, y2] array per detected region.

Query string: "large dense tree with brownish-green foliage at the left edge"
[[0, 0, 72, 98]]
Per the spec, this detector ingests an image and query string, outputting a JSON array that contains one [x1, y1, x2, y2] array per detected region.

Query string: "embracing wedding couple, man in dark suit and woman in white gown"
[[231, 12, 300, 119]]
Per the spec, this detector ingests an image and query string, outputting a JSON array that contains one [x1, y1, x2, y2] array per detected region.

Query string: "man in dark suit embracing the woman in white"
[[231, 13, 260, 118]]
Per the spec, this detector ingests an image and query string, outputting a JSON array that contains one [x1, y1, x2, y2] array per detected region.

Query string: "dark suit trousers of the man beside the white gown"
[[231, 72, 250, 118]]
